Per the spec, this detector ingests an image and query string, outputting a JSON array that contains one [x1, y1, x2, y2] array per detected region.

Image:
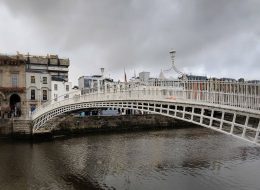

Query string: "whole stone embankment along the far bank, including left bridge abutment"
[[0, 114, 200, 139]]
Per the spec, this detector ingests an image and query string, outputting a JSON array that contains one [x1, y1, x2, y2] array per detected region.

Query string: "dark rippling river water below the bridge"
[[0, 128, 260, 190]]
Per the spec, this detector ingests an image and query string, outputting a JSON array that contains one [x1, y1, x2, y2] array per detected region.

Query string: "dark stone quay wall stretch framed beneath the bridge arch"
[[49, 115, 197, 135]]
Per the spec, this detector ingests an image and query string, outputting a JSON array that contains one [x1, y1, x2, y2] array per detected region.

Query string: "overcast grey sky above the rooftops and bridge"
[[0, 0, 260, 84]]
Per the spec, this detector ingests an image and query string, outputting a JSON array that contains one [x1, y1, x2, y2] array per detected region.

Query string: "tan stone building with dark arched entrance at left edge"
[[0, 55, 27, 118]]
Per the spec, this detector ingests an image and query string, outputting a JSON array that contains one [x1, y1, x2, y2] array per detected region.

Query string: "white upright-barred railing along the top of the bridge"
[[32, 81, 260, 119]]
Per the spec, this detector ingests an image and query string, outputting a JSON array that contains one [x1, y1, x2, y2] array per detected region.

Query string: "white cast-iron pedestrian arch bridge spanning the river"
[[31, 81, 260, 145]]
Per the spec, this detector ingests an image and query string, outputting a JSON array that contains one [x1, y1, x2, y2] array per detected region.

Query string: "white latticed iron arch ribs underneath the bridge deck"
[[33, 100, 260, 144]]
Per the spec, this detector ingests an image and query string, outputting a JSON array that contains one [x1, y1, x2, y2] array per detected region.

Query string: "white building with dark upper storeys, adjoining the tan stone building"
[[23, 54, 71, 111]]
